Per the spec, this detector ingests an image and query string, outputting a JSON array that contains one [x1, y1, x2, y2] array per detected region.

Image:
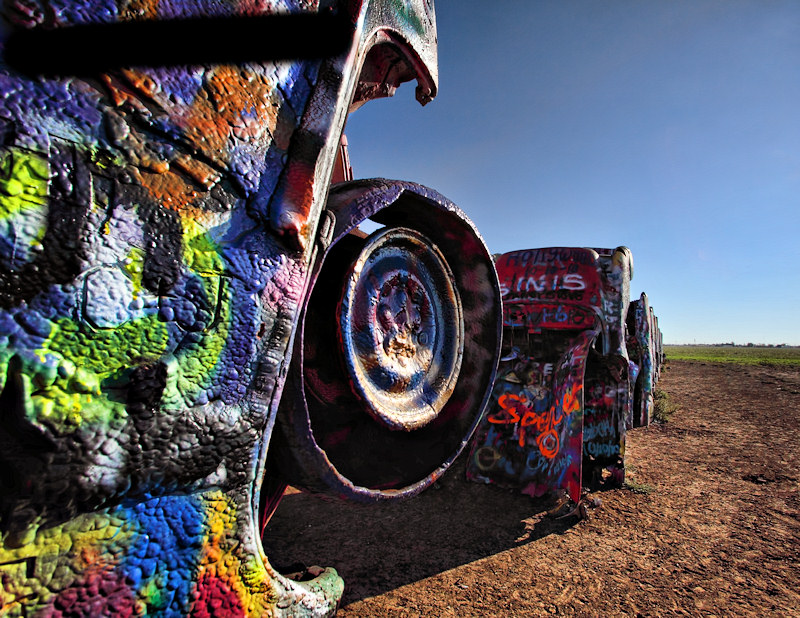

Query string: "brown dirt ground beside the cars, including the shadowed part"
[[267, 361, 800, 617]]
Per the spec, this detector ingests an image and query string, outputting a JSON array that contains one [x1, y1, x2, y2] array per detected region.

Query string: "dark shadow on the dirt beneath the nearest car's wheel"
[[264, 457, 577, 604]]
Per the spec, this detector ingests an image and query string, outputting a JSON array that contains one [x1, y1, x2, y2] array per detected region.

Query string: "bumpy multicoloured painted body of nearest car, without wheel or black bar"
[[0, 0, 444, 616]]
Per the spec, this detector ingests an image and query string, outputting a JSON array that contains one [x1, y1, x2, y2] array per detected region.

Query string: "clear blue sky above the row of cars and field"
[[346, 0, 800, 345]]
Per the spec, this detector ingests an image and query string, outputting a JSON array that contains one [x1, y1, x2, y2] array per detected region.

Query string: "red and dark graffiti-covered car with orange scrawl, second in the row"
[[467, 247, 637, 502]]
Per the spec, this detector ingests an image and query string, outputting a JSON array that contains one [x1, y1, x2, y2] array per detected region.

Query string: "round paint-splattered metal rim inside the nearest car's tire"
[[338, 227, 464, 431]]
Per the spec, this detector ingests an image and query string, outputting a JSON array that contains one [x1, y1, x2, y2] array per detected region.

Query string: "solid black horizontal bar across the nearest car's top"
[[4, 13, 354, 77]]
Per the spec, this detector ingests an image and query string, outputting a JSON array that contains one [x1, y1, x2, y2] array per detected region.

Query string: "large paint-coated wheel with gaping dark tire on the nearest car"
[[267, 190, 501, 501]]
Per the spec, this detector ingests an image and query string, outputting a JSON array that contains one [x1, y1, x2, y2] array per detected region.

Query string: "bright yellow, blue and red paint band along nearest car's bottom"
[[1, 491, 300, 616]]
